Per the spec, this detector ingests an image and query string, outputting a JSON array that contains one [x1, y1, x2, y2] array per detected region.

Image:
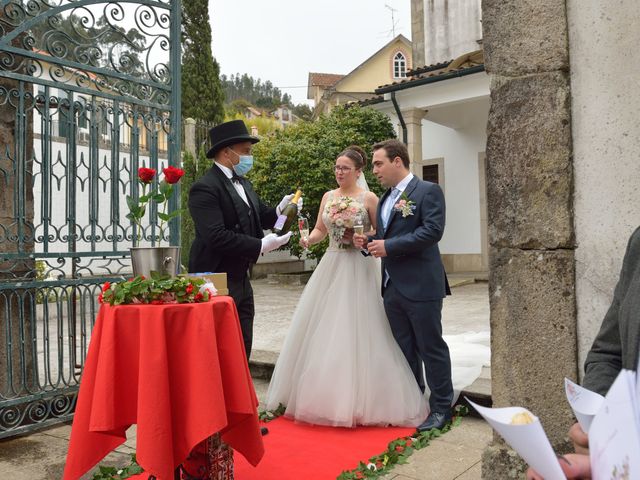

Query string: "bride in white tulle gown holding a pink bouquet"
[[266, 146, 428, 427]]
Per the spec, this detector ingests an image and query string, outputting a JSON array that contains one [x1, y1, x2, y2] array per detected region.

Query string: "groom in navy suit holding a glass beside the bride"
[[354, 140, 453, 431]]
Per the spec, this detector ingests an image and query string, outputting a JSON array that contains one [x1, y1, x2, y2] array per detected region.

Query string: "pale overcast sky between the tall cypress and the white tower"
[[209, 0, 411, 103]]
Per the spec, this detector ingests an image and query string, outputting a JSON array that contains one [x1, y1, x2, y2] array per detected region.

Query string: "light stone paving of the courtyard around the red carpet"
[[0, 276, 492, 480]]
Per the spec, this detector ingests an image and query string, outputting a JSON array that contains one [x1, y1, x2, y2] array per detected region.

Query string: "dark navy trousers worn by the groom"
[[383, 281, 453, 413]]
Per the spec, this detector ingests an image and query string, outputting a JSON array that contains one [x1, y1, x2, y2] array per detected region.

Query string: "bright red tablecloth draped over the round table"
[[63, 297, 264, 480]]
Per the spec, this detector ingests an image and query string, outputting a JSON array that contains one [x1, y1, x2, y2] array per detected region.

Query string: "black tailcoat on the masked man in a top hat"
[[189, 164, 277, 279]]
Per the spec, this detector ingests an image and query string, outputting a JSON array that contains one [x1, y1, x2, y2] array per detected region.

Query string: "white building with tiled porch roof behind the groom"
[[365, 0, 489, 273]]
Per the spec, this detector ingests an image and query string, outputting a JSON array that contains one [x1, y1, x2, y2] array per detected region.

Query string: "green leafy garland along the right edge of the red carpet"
[[336, 405, 469, 480]]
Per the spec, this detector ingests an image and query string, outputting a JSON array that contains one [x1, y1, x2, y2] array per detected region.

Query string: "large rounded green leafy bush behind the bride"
[[249, 107, 395, 258]]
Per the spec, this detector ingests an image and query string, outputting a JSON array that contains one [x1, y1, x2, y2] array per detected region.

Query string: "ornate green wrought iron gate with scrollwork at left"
[[0, 0, 180, 438]]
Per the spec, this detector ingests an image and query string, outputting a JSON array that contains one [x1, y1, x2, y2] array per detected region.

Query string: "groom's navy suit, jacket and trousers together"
[[374, 177, 453, 413]]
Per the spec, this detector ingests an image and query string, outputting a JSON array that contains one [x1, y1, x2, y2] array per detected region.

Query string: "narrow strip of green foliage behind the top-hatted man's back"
[[180, 147, 212, 266]]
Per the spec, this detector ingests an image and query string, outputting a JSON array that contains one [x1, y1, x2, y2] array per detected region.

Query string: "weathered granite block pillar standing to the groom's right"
[[482, 0, 578, 479]]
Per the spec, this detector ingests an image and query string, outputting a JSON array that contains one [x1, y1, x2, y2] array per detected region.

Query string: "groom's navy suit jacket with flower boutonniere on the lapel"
[[374, 177, 451, 301]]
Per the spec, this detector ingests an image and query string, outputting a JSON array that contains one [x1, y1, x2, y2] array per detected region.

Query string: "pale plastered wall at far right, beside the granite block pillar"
[[567, 0, 640, 371]]
